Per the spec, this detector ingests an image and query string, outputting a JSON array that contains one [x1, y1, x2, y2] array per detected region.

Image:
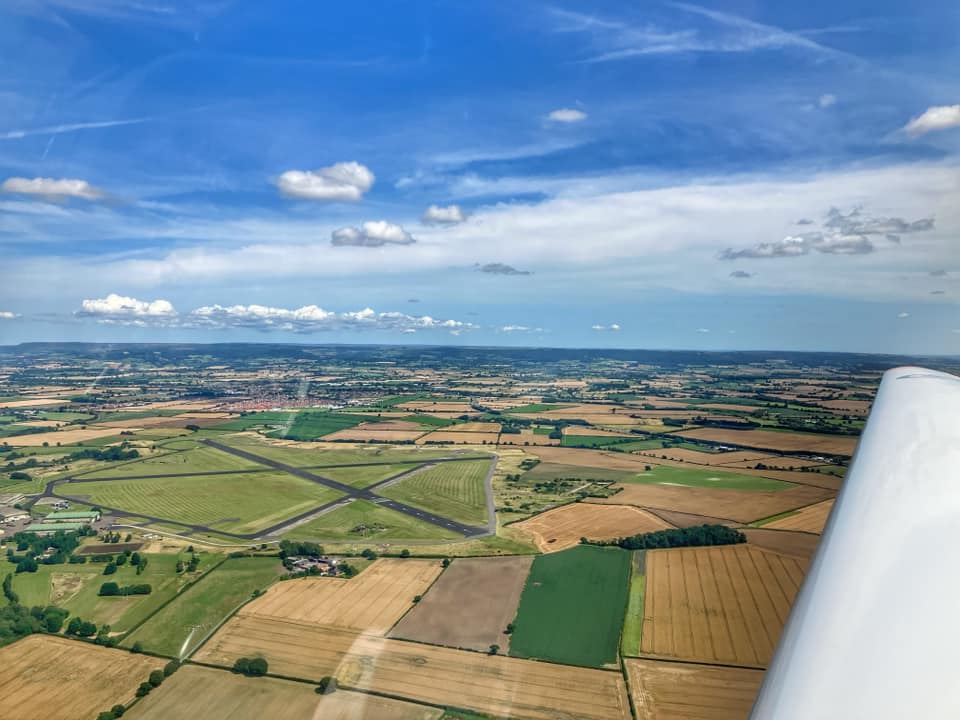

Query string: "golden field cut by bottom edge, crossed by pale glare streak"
[[124, 665, 443, 720]]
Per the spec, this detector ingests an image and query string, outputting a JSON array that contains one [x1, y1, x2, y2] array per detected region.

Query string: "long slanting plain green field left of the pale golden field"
[[121, 557, 286, 657]]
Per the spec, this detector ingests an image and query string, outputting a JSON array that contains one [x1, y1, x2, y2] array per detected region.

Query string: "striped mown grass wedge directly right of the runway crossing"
[[378, 460, 490, 525]]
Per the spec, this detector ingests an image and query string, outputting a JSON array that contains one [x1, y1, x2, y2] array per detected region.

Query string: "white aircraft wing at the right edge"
[[751, 367, 960, 720]]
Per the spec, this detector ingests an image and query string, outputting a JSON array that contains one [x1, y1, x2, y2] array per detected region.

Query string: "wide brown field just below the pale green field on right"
[[587, 483, 834, 523]]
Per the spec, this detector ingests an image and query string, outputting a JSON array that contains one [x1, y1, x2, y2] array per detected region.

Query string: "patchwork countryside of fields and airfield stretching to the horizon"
[[0, 344, 952, 720]]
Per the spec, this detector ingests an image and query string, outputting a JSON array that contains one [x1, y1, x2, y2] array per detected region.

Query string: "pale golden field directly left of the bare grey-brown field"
[[240, 558, 442, 635]]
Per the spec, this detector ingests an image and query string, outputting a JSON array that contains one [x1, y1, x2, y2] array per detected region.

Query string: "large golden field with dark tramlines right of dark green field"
[[641, 545, 807, 667]]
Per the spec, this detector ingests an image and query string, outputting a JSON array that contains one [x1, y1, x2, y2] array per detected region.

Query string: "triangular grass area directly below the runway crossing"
[[285, 500, 460, 542]]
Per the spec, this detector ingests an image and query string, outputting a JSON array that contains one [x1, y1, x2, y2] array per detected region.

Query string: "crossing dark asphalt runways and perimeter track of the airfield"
[[34, 440, 497, 540]]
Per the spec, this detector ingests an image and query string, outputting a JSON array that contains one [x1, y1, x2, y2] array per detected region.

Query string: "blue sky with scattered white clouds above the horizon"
[[0, 0, 960, 354]]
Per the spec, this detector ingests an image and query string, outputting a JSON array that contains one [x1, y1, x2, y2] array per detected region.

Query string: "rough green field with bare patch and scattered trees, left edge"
[[0, 553, 216, 632]]
